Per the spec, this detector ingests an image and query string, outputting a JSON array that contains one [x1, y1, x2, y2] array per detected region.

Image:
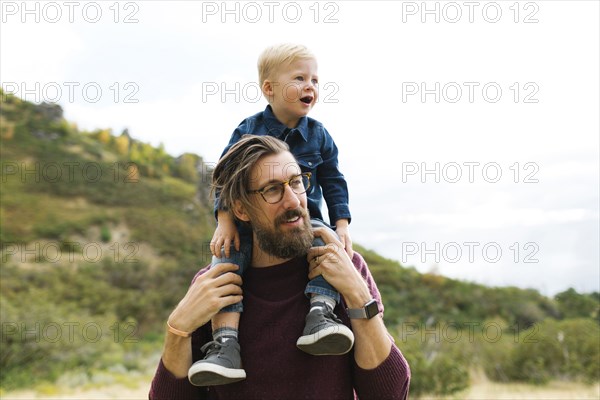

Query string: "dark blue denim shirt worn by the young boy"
[[215, 105, 351, 225]]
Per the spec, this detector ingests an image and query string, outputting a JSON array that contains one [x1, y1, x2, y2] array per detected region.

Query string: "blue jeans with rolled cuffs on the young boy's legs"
[[211, 218, 340, 312]]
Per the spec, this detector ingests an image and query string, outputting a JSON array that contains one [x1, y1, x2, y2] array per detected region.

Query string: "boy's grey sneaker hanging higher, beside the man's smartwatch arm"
[[296, 303, 354, 356]]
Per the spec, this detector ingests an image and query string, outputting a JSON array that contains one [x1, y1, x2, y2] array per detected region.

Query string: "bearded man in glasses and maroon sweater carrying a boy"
[[150, 135, 410, 400]]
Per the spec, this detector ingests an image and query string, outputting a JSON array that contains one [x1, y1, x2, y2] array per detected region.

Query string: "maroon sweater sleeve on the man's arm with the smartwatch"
[[352, 252, 410, 400]]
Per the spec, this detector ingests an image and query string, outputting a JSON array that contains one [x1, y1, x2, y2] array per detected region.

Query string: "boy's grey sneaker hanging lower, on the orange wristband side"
[[188, 339, 246, 386]]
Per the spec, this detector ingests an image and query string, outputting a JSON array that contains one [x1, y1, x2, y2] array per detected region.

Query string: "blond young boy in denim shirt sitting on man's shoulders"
[[188, 44, 354, 386]]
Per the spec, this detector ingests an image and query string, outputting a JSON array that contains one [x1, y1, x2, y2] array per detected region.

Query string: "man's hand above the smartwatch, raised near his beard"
[[307, 228, 371, 308]]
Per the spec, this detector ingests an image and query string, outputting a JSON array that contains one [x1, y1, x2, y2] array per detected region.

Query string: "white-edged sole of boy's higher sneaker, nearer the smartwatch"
[[296, 325, 354, 356]]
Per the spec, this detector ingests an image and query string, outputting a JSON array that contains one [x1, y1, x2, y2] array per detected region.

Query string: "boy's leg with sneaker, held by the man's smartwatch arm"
[[296, 219, 354, 355]]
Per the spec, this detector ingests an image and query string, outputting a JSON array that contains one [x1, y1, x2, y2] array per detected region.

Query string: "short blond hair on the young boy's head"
[[258, 43, 316, 87]]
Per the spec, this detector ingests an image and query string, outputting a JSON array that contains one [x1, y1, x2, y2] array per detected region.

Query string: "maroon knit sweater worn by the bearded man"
[[149, 252, 410, 400]]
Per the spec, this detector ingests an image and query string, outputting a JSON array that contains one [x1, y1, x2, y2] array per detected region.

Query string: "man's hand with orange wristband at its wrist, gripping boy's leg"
[[169, 263, 242, 332]]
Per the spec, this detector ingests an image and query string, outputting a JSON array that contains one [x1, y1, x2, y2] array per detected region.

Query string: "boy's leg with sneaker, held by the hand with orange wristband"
[[188, 232, 252, 386]]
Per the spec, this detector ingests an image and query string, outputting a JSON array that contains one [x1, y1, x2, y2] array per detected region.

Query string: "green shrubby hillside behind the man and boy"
[[0, 92, 600, 395]]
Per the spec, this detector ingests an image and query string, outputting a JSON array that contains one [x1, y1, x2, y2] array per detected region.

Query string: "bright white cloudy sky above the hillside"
[[0, 0, 600, 295]]
